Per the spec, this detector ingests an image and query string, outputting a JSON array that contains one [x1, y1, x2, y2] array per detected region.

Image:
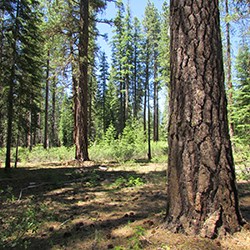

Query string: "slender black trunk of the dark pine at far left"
[[5, 0, 20, 171]]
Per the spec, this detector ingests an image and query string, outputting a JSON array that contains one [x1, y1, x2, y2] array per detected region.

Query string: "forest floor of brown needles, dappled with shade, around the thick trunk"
[[0, 161, 250, 250]]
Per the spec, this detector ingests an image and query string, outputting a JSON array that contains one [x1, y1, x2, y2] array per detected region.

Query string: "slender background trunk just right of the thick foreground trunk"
[[225, 0, 234, 141]]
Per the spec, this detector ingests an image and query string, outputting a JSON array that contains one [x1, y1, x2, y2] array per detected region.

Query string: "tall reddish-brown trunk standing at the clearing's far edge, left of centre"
[[75, 0, 89, 161]]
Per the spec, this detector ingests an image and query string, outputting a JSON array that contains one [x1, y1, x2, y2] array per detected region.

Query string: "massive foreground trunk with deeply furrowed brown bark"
[[166, 0, 242, 238]]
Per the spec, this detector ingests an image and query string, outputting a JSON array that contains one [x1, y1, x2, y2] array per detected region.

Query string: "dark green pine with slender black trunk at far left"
[[4, 0, 41, 169]]
